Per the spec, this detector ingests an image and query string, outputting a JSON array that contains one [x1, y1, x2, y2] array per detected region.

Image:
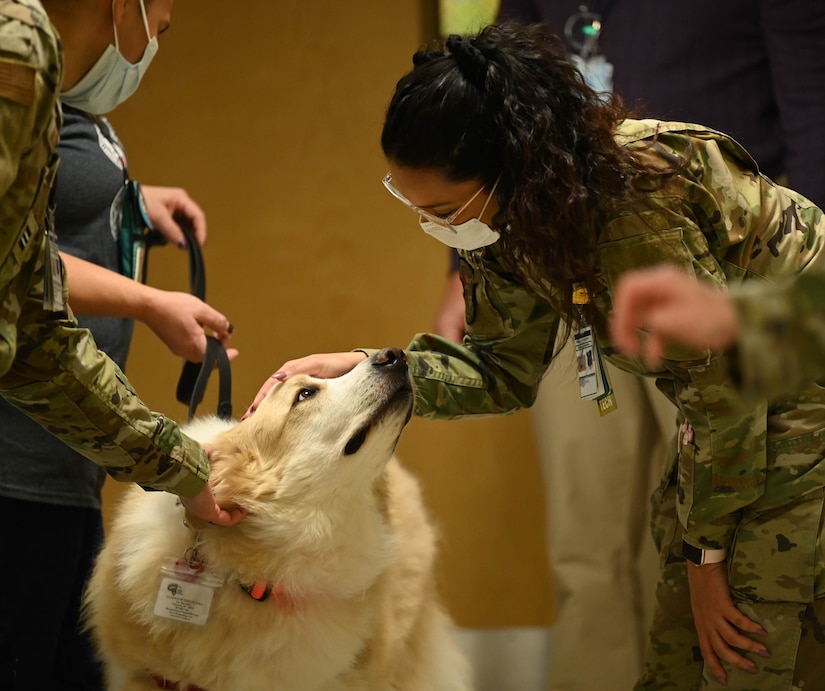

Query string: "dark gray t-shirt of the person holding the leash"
[[0, 106, 134, 508]]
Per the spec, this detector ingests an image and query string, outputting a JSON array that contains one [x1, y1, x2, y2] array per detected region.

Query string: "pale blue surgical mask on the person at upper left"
[[60, 0, 158, 115]]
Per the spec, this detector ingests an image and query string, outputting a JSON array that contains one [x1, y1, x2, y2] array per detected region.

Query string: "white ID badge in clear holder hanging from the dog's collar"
[[154, 559, 224, 626]]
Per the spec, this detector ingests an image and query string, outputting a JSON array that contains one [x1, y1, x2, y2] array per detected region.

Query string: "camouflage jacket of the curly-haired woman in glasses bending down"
[[366, 120, 825, 549]]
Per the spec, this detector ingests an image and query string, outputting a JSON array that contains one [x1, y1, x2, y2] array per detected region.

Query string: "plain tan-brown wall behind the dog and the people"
[[107, 0, 553, 627]]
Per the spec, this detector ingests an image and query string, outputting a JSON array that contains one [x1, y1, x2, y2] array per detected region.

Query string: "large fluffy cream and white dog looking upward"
[[86, 349, 471, 691]]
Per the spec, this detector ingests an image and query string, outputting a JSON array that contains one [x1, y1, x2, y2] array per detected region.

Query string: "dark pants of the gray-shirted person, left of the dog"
[[0, 497, 104, 691]]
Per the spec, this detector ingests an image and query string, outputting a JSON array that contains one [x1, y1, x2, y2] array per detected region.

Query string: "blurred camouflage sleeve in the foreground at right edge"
[[732, 271, 825, 398]]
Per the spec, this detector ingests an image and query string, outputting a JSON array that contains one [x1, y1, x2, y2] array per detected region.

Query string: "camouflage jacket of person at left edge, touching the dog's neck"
[[0, 0, 208, 496]]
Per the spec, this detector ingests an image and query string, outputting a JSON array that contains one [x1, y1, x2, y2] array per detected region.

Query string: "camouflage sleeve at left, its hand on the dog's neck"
[[0, 249, 209, 496]]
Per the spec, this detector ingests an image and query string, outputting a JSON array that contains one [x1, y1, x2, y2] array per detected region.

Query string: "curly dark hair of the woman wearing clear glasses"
[[381, 23, 683, 336]]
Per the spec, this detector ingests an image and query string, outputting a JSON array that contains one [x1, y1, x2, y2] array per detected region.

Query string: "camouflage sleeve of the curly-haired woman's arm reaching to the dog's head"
[[364, 245, 559, 419]]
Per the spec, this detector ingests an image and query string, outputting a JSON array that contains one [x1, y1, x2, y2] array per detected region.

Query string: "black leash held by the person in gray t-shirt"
[[175, 223, 232, 421]]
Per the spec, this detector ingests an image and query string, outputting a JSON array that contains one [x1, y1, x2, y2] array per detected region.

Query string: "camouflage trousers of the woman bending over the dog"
[[635, 483, 825, 691]]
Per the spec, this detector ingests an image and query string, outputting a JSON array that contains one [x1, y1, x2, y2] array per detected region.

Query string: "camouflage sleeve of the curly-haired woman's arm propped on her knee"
[[663, 128, 822, 549]]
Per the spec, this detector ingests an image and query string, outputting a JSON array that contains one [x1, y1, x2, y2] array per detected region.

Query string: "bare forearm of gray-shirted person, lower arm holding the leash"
[[60, 252, 157, 320]]
